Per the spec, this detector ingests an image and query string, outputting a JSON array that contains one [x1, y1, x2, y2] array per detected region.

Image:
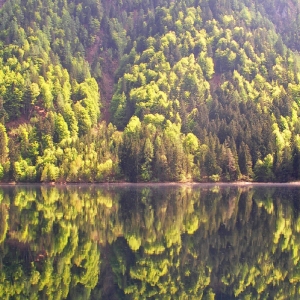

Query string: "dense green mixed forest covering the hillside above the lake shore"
[[0, 0, 300, 182]]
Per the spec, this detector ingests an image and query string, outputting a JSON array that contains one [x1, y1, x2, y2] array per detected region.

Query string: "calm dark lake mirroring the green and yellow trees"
[[0, 184, 300, 300]]
